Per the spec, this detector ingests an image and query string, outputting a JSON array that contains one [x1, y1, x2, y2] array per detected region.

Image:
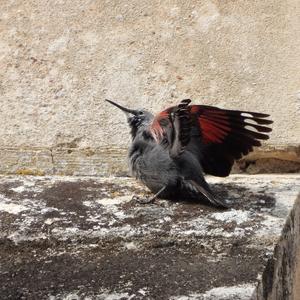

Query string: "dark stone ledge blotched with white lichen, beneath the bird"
[[0, 175, 300, 300]]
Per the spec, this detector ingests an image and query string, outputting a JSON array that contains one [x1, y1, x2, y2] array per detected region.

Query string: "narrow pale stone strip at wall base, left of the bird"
[[0, 147, 128, 176]]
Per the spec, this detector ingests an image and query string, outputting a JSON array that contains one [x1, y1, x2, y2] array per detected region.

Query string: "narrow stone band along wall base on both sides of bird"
[[0, 146, 300, 176]]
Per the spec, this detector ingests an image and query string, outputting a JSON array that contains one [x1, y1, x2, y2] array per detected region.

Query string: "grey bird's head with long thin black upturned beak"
[[106, 99, 153, 138]]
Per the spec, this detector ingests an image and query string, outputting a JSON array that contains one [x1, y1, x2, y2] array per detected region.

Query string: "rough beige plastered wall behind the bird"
[[0, 0, 300, 174]]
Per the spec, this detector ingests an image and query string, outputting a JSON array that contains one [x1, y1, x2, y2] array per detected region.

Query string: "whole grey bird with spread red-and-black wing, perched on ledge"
[[106, 99, 273, 207]]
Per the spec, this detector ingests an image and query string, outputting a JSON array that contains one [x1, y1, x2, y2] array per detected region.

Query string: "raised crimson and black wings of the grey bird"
[[151, 100, 273, 177]]
